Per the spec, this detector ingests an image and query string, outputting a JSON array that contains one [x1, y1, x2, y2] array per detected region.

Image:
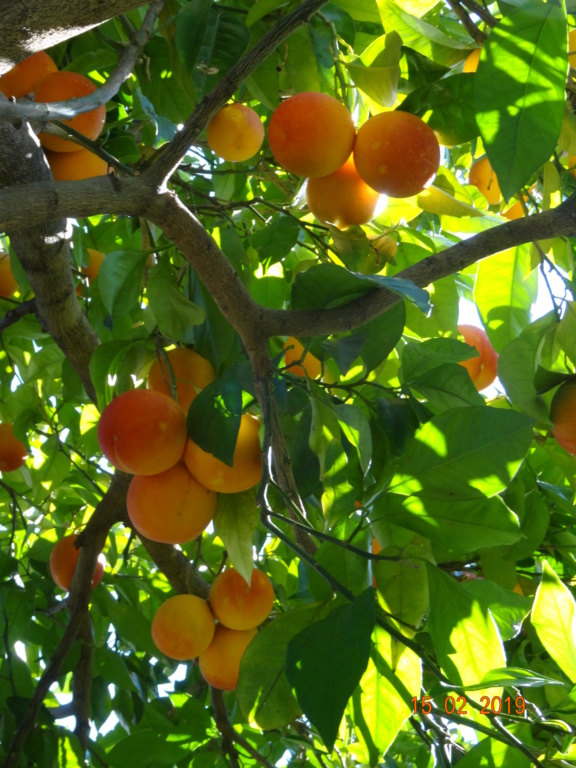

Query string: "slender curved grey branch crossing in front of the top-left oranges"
[[0, 0, 165, 123]]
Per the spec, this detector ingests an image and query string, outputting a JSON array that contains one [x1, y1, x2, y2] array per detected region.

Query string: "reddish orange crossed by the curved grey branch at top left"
[[34, 72, 106, 152]]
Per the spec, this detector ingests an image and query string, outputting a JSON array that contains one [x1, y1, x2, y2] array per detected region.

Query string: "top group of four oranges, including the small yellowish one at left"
[[207, 91, 440, 227]]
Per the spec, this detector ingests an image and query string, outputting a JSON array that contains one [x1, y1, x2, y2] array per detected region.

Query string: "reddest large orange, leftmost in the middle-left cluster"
[[98, 389, 188, 475]]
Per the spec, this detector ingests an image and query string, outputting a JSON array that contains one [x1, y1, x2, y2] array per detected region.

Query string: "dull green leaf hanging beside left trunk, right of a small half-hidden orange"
[[96, 251, 148, 317]]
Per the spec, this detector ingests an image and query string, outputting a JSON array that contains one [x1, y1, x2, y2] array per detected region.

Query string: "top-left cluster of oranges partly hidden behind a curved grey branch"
[[0, 51, 108, 181]]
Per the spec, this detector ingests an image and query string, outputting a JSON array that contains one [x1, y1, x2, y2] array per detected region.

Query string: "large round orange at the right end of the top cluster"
[[354, 111, 440, 197]]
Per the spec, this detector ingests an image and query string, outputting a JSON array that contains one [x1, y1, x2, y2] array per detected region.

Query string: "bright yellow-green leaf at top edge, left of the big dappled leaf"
[[377, 0, 467, 66]]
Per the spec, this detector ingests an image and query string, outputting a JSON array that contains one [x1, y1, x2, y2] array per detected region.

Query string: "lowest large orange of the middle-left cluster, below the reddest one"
[[126, 462, 217, 544]]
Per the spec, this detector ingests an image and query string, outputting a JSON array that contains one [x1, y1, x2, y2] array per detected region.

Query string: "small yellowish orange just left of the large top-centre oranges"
[[206, 104, 264, 163]]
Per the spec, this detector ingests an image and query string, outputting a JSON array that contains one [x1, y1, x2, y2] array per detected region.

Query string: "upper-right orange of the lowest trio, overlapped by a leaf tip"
[[209, 568, 274, 629]]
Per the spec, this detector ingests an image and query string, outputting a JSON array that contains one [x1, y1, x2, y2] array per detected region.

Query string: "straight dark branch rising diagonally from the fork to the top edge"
[[146, 0, 328, 187]]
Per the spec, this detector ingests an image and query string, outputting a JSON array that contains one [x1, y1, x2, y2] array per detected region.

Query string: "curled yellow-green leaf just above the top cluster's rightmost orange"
[[346, 31, 402, 107]]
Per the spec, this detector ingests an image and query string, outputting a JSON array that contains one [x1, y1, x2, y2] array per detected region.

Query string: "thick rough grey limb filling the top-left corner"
[[0, 0, 145, 75]]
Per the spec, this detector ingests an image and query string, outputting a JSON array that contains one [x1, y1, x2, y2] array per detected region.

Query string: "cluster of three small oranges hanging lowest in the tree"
[[152, 568, 274, 691]]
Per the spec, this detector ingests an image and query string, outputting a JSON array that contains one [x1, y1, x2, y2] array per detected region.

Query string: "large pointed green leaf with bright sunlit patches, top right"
[[474, 0, 568, 200]]
